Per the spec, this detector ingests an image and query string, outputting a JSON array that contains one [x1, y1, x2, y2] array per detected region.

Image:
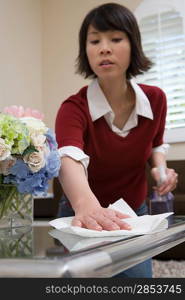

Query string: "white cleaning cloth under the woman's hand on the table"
[[49, 199, 173, 237]]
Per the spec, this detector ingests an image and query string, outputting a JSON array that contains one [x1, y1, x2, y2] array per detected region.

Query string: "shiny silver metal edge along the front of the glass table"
[[0, 222, 185, 278]]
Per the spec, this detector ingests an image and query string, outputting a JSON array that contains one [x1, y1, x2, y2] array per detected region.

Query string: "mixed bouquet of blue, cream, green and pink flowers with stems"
[[0, 106, 60, 232]]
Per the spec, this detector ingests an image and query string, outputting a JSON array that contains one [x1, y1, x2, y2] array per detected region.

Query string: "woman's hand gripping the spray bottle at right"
[[151, 168, 178, 196]]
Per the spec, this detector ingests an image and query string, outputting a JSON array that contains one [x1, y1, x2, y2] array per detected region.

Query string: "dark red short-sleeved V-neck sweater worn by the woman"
[[56, 85, 166, 209]]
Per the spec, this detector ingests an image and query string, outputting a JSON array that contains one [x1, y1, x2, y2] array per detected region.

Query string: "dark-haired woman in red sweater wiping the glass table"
[[56, 3, 177, 277]]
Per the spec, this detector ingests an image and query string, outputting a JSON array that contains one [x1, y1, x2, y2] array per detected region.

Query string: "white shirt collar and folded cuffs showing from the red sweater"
[[59, 79, 169, 171]]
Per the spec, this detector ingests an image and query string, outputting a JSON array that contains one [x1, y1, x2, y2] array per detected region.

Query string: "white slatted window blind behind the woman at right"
[[135, 9, 185, 142]]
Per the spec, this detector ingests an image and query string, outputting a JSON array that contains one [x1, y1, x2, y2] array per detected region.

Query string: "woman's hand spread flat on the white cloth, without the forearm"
[[72, 204, 131, 231]]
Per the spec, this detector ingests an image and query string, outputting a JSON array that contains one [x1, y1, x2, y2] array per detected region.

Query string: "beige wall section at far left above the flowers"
[[0, 0, 43, 111]]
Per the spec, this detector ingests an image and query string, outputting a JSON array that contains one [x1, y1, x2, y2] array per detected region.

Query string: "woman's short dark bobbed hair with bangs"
[[76, 3, 152, 79]]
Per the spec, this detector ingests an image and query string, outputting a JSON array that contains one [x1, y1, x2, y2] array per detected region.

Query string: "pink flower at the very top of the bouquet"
[[3, 105, 44, 120]]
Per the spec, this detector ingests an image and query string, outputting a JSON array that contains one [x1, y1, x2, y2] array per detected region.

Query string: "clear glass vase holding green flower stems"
[[0, 184, 33, 236]]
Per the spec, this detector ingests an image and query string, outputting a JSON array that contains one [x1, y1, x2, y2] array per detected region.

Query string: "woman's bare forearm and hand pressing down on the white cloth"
[[59, 157, 131, 231]]
